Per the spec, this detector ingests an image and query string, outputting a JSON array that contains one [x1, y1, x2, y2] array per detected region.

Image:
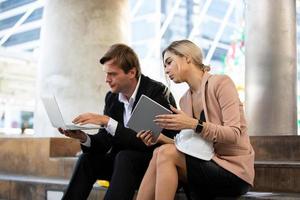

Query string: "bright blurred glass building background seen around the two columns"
[[0, 0, 300, 135]]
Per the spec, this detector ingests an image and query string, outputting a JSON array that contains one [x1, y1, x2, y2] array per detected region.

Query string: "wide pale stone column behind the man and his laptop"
[[34, 0, 128, 136]]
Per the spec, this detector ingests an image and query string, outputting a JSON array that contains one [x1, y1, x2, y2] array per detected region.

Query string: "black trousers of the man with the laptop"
[[62, 150, 152, 200]]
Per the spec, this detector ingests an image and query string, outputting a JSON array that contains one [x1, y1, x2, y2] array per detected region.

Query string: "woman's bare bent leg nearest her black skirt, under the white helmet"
[[155, 144, 187, 200]]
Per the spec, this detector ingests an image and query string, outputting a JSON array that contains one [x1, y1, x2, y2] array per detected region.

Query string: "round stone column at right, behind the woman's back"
[[246, 0, 297, 135]]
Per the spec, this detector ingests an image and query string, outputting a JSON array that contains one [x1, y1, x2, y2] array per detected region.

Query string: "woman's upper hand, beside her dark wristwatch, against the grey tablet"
[[154, 106, 198, 130]]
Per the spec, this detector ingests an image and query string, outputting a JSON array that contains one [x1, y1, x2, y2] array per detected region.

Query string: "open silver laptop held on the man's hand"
[[41, 96, 102, 130]]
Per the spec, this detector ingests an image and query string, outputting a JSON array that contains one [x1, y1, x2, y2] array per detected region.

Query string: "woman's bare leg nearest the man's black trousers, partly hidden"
[[136, 148, 158, 200]]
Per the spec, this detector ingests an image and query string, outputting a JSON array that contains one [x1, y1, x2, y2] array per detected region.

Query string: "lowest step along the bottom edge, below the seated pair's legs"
[[0, 174, 300, 200]]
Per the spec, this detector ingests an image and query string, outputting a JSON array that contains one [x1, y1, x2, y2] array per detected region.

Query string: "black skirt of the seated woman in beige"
[[185, 154, 251, 200]]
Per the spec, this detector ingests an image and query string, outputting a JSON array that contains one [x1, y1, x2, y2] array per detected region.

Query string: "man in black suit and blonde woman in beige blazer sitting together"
[[59, 40, 254, 200]]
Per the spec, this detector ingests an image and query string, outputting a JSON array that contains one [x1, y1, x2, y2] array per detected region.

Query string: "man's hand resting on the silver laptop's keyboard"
[[72, 113, 109, 126]]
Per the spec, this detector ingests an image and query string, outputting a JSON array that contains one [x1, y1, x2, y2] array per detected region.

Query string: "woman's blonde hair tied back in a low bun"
[[162, 40, 210, 71]]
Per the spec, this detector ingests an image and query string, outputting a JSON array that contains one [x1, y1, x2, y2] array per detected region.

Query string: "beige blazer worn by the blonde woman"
[[180, 72, 254, 185]]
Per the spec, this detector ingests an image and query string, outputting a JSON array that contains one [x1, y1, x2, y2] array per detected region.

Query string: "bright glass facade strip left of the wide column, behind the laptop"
[[0, 0, 43, 134]]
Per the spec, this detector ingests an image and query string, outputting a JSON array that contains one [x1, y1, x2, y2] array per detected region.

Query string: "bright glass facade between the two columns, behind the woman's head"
[[130, 0, 245, 99]]
